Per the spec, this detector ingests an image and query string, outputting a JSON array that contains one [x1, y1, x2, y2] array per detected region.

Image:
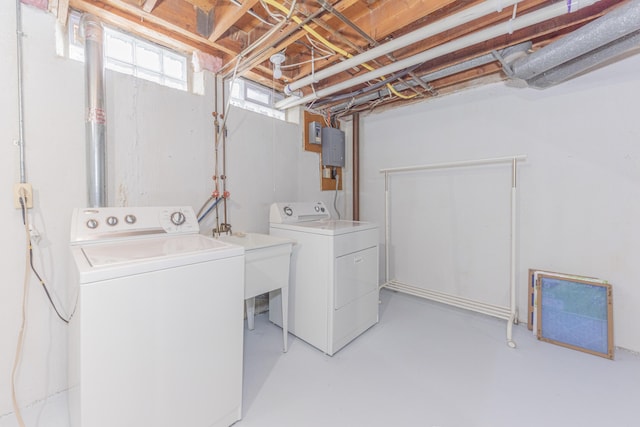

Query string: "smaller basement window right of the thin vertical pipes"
[[229, 78, 285, 120]]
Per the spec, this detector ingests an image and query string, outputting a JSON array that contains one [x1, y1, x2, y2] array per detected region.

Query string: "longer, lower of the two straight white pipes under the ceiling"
[[276, 0, 599, 109]]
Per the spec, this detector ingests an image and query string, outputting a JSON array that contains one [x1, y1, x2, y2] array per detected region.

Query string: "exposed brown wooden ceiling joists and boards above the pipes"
[[62, 0, 629, 113]]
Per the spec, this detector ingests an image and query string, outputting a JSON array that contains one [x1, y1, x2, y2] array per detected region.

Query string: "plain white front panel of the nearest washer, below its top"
[[70, 256, 244, 427]]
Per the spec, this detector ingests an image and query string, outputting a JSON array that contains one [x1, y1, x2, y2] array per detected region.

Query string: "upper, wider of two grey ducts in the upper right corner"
[[511, 0, 640, 80]]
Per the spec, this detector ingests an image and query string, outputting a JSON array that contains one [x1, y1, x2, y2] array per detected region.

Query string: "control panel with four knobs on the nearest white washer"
[[71, 206, 200, 243]]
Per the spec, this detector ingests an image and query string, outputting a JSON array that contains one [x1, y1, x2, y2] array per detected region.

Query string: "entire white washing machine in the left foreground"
[[69, 206, 244, 427]]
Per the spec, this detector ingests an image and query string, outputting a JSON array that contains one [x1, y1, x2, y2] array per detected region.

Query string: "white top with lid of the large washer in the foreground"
[[71, 234, 244, 283]]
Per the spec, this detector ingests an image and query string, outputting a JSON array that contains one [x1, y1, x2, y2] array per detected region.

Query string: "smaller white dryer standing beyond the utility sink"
[[269, 202, 379, 356]]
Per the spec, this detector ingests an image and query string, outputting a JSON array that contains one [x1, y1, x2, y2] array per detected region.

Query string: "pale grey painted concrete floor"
[[0, 290, 640, 427]]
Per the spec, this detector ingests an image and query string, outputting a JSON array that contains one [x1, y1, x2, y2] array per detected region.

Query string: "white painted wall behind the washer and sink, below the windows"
[[0, 6, 329, 417]]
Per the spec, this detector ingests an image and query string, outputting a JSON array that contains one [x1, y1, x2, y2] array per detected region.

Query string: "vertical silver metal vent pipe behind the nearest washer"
[[82, 14, 107, 207]]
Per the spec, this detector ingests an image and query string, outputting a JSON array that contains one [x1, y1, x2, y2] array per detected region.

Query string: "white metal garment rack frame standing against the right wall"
[[380, 155, 527, 348]]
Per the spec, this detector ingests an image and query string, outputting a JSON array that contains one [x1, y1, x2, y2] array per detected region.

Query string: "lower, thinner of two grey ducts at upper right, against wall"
[[527, 31, 640, 89]]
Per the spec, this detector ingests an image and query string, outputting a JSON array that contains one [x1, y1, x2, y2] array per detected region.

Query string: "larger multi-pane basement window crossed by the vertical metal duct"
[[68, 12, 188, 91]]
